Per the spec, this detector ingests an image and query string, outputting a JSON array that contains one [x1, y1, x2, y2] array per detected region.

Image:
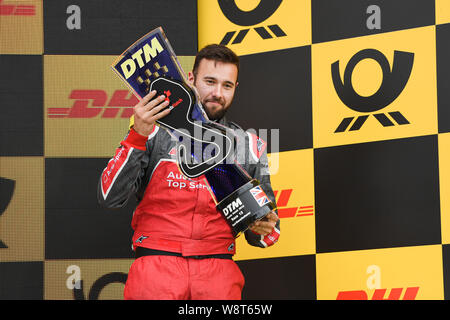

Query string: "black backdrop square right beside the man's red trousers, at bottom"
[[236, 255, 316, 300]]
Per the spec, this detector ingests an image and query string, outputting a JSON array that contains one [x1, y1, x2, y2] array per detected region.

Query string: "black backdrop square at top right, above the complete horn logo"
[[311, 0, 435, 43]]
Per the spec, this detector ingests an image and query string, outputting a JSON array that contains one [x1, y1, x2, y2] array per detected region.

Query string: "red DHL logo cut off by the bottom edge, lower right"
[[336, 287, 419, 300]]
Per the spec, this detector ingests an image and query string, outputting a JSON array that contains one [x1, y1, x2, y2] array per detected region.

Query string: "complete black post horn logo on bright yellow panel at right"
[[331, 49, 414, 133]]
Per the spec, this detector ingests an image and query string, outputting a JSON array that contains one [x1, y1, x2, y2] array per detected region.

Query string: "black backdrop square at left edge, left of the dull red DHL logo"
[[0, 55, 44, 156]]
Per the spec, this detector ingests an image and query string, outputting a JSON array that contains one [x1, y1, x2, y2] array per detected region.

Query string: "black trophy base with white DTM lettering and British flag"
[[216, 179, 275, 237]]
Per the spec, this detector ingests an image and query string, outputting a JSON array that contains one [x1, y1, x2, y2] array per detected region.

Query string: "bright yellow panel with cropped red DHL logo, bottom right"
[[316, 245, 444, 300]]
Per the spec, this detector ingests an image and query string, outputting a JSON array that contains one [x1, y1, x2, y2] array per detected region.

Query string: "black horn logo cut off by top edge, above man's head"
[[218, 0, 286, 45]]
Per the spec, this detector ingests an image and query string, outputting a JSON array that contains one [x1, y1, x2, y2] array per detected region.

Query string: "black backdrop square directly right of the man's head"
[[227, 46, 312, 152]]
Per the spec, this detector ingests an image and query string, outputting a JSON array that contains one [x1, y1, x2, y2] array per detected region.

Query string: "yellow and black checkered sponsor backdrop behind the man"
[[0, 0, 450, 300]]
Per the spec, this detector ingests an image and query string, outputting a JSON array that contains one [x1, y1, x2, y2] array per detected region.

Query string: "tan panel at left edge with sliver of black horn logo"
[[0, 157, 45, 261]]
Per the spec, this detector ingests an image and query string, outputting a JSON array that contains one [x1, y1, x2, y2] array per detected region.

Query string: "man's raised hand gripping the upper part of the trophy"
[[133, 90, 170, 136]]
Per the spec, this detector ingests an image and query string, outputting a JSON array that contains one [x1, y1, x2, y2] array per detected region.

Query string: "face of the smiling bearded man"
[[188, 59, 238, 120]]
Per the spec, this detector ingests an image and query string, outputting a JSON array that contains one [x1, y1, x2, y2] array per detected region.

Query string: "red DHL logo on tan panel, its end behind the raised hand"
[[47, 90, 138, 118]]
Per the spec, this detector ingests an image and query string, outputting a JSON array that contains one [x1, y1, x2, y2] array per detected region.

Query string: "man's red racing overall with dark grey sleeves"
[[98, 119, 280, 300]]
